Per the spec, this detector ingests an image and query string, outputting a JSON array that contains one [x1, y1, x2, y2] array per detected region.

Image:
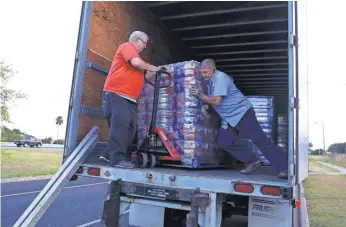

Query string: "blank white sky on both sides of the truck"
[[0, 1, 346, 148]]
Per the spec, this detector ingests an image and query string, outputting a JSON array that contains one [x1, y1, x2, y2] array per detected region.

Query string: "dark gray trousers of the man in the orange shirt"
[[102, 92, 137, 164]]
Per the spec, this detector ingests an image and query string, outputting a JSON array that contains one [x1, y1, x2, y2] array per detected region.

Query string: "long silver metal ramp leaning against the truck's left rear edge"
[[14, 126, 99, 227]]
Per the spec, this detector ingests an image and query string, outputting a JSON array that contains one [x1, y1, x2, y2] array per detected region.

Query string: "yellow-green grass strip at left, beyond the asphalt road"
[[1, 148, 63, 179]]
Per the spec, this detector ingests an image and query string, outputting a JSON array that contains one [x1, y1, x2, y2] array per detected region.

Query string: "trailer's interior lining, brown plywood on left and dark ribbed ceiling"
[[64, 2, 289, 184]]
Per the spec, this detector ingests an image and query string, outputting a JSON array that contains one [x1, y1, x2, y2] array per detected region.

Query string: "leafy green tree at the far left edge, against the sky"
[[0, 61, 26, 123]]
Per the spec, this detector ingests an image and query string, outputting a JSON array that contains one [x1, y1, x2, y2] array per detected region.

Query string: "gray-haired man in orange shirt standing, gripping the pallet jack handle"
[[100, 31, 159, 168]]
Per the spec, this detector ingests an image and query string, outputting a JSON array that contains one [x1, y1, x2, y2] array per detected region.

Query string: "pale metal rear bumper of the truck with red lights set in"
[[78, 164, 292, 200]]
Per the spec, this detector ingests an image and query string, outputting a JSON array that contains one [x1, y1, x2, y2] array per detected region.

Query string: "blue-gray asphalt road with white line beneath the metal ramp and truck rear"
[[1, 178, 247, 227]]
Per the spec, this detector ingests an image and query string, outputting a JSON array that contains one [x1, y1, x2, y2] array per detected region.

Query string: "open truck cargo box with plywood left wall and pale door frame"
[[64, 2, 308, 190]]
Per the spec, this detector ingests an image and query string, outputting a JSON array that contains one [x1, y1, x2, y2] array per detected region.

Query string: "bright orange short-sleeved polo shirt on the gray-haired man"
[[103, 42, 144, 99]]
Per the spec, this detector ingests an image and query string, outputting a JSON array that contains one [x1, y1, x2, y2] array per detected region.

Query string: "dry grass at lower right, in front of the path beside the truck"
[[304, 175, 346, 227]]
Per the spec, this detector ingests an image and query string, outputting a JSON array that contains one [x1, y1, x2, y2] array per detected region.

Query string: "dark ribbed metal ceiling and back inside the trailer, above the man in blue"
[[145, 2, 289, 113]]
